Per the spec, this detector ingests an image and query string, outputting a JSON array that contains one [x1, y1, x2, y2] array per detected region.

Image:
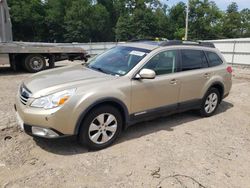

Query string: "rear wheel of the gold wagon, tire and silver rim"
[[200, 88, 221, 117]]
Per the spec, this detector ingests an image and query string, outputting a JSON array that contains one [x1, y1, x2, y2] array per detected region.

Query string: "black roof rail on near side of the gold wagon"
[[160, 40, 215, 48]]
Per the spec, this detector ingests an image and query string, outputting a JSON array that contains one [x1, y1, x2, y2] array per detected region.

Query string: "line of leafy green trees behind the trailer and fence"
[[8, 0, 250, 42]]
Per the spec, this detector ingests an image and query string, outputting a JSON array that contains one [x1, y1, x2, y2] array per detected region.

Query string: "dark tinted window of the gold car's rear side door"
[[181, 50, 208, 71]]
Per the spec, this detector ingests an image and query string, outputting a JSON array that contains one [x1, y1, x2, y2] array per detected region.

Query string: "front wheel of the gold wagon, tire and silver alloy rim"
[[78, 105, 122, 150]]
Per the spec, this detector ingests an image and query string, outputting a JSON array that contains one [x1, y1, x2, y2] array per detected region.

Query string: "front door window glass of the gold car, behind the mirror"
[[143, 50, 178, 75]]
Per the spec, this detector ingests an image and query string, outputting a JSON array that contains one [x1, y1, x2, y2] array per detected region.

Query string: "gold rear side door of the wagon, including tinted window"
[[179, 49, 211, 106]]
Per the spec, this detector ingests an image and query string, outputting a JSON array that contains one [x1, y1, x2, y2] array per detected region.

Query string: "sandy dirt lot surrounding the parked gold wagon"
[[0, 62, 250, 188]]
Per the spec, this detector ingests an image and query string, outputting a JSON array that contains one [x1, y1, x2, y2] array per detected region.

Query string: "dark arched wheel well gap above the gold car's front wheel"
[[75, 101, 128, 134]]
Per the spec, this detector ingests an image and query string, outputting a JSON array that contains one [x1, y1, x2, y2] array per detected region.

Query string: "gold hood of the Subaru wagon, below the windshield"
[[24, 65, 115, 98]]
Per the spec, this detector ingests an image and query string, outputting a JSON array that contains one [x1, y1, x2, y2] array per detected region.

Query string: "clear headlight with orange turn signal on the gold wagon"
[[31, 89, 76, 109]]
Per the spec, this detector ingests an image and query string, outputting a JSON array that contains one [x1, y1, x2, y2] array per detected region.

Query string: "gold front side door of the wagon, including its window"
[[131, 50, 180, 117]]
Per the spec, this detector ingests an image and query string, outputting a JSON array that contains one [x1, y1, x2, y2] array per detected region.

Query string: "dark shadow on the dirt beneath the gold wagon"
[[34, 101, 234, 155]]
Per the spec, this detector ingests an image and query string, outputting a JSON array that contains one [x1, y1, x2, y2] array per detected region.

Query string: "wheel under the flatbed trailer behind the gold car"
[[24, 54, 46, 73]]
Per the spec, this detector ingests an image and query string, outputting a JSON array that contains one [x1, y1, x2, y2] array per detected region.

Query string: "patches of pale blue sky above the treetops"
[[162, 0, 250, 10]]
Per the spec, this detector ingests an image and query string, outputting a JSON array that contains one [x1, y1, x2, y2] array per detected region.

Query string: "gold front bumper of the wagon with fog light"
[[14, 90, 76, 138]]
